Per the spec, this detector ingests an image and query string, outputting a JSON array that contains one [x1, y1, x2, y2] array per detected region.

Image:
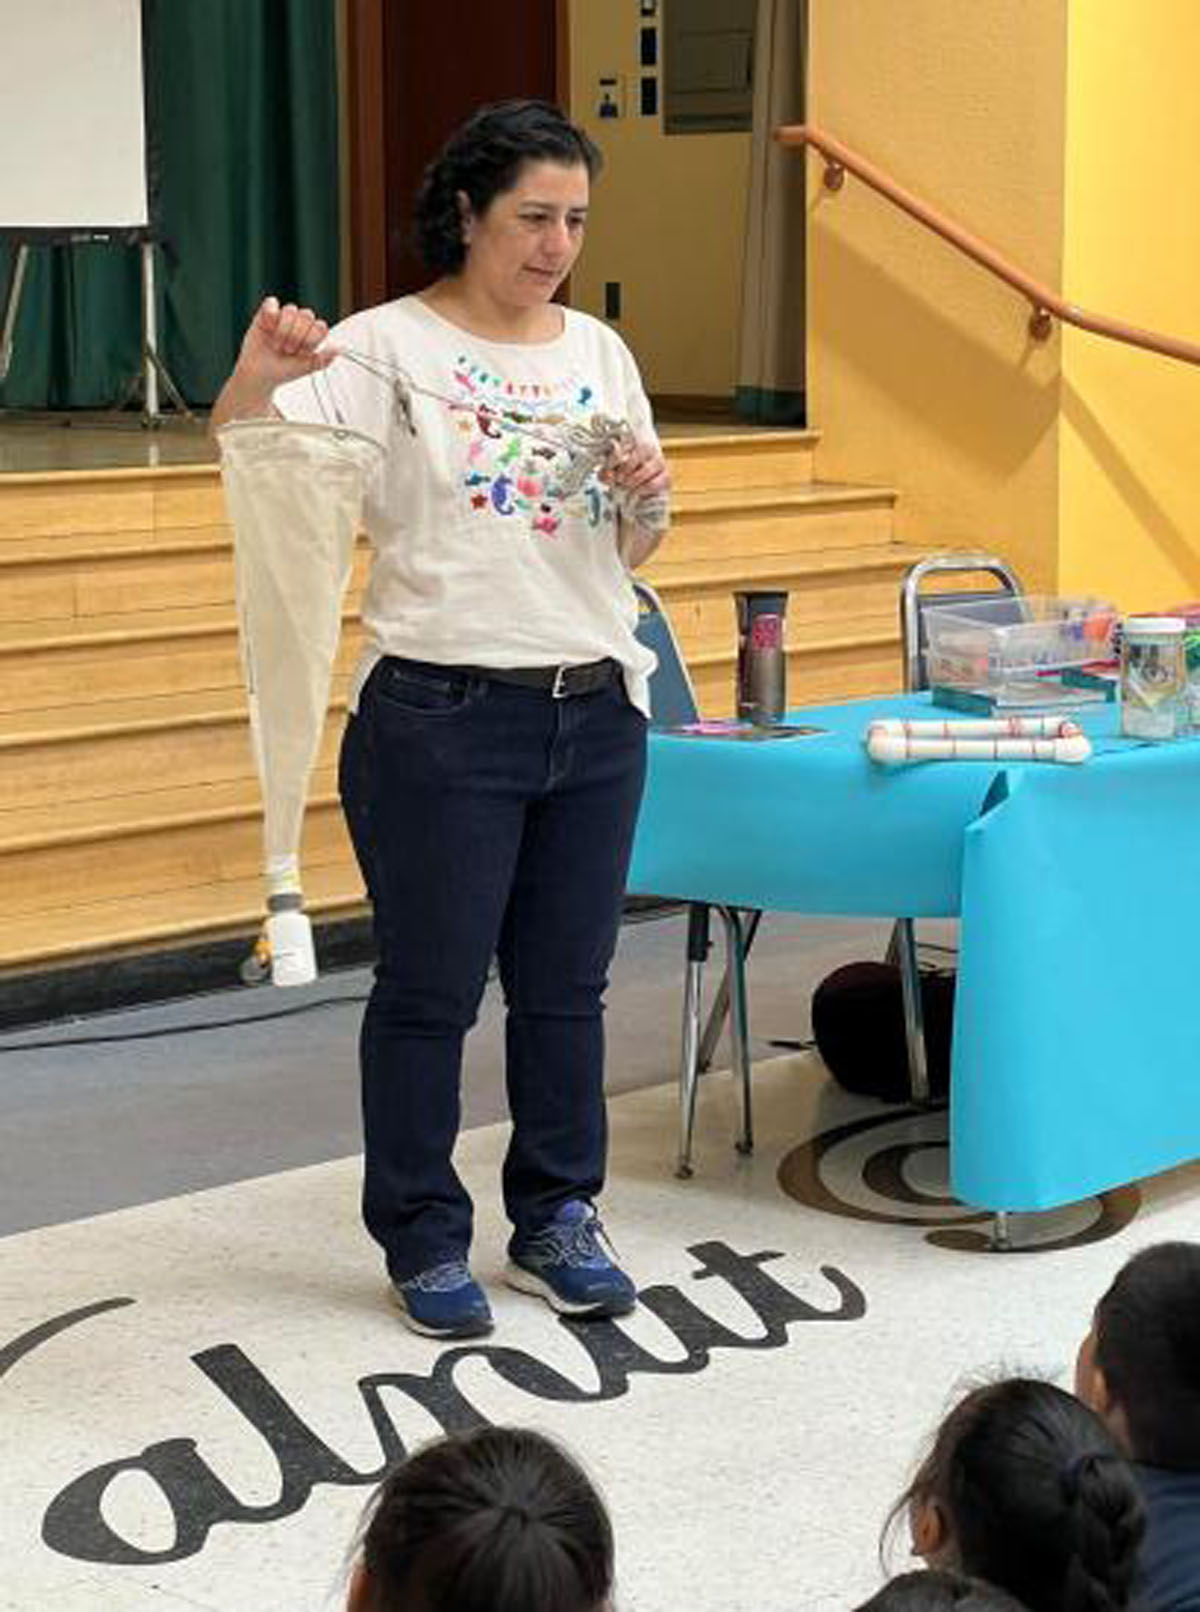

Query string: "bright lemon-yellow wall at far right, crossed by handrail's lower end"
[[1060, 0, 1200, 609]]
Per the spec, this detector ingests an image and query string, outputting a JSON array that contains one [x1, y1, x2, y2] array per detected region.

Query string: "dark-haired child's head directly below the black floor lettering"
[[350, 1427, 613, 1612]]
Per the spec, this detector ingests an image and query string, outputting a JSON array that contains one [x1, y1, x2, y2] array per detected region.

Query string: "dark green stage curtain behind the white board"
[[0, 0, 339, 408]]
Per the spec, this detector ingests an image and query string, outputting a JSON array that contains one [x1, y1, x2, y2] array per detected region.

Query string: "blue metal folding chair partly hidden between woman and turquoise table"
[[634, 580, 761, 1180]]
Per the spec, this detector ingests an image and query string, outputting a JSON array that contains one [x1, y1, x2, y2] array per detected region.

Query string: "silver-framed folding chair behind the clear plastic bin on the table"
[[887, 555, 1021, 1104]]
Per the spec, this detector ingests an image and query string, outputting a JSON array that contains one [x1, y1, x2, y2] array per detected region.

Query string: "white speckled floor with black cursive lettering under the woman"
[[0, 1056, 1200, 1612]]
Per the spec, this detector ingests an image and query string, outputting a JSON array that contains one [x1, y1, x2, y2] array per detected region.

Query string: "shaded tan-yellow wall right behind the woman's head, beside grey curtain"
[[569, 0, 750, 397]]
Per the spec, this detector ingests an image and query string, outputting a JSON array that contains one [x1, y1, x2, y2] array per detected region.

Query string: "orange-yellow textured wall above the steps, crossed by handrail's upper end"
[[797, 0, 1066, 587]]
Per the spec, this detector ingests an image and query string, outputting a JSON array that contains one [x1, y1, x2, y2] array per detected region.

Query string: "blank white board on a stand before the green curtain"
[[0, 0, 150, 237]]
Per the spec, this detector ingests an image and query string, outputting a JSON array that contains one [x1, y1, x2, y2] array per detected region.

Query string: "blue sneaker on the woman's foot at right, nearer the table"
[[505, 1198, 637, 1315]]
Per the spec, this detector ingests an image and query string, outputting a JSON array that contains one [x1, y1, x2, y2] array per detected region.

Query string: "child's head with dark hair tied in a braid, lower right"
[[892, 1377, 1144, 1612]]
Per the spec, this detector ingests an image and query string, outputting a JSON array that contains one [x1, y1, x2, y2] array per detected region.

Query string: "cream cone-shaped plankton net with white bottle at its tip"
[[218, 419, 384, 985]]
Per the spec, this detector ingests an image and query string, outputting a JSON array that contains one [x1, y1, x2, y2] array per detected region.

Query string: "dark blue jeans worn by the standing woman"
[[339, 658, 645, 1280]]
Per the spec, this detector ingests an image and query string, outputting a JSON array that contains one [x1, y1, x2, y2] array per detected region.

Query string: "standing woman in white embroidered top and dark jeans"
[[213, 102, 668, 1338]]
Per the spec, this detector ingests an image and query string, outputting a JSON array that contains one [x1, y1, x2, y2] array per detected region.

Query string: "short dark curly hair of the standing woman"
[[413, 100, 603, 274]]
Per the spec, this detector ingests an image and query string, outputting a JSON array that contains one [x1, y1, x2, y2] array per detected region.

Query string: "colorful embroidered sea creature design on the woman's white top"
[[447, 353, 616, 538]]
